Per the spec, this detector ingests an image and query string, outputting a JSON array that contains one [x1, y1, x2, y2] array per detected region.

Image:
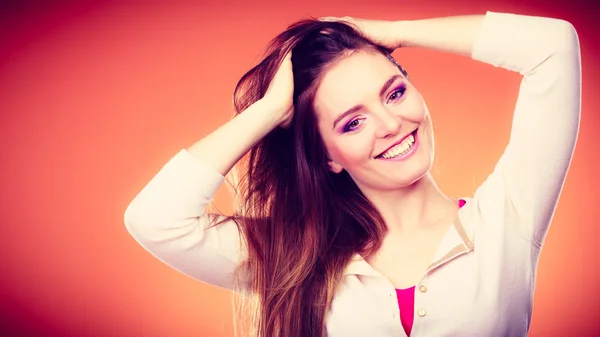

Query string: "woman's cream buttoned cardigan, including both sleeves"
[[125, 12, 581, 337]]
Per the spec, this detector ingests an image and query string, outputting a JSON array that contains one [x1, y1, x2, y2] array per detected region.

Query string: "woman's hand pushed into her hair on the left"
[[261, 50, 294, 128]]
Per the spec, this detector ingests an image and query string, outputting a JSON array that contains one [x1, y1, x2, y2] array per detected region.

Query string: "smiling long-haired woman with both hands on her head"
[[125, 12, 581, 336]]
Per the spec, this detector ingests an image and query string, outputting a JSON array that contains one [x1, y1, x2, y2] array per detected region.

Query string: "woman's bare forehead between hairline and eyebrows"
[[314, 51, 400, 120]]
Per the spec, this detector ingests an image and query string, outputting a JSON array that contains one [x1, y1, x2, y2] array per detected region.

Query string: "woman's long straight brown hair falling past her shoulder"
[[223, 19, 405, 337]]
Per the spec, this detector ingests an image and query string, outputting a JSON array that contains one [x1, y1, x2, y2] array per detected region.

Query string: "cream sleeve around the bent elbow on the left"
[[124, 150, 242, 289]]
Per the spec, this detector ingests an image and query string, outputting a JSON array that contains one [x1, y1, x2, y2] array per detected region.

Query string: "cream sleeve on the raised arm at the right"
[[471, 12, 581, 246]]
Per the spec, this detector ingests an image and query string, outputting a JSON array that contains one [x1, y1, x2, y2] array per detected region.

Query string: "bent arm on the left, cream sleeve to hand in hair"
[[124, 55, 293, 289]]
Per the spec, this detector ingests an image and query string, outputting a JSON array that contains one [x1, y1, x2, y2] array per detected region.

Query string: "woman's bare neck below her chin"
[[363, 173, 458, 234]]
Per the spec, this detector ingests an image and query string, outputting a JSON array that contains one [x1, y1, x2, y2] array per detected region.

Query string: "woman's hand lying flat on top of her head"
[[319, 16, 402, 52]]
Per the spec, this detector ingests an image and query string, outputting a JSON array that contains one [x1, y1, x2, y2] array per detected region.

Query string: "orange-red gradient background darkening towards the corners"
[[0, 0, 600, 336]]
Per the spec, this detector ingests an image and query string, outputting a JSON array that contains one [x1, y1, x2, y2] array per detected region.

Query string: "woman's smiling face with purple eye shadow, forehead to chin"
[[314, 51, 434, 193]]
